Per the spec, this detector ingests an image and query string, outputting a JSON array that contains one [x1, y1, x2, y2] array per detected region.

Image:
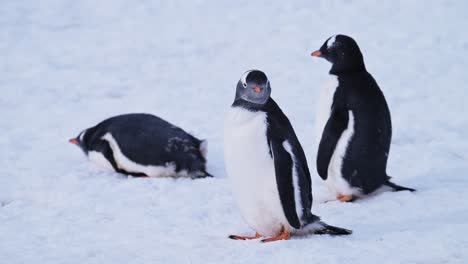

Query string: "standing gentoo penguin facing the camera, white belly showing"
[[224, 70, 351, 242]]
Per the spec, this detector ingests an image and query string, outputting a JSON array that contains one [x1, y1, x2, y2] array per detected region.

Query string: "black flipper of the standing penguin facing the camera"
[[270, 139, 302, 229]]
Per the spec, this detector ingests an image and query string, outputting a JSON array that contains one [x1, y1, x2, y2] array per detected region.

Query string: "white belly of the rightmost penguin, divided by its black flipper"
[[315, 75, 360, 195]]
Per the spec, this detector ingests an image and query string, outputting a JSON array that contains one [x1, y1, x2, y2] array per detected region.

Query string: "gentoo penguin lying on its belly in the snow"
[[69, 114, 211, 178]]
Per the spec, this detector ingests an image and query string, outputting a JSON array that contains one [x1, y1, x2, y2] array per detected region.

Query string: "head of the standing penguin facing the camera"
[[235, 70, 271, 106]]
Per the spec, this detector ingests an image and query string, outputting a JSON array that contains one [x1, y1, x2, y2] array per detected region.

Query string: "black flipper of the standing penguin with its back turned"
[[317, 109, 349, 180]]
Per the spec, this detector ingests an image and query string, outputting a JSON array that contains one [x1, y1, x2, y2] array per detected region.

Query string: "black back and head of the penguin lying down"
[[79, 114, 206, 172]]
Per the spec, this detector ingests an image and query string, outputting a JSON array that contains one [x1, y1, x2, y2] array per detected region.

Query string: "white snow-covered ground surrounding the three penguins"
[[0, 0, 468, 264]]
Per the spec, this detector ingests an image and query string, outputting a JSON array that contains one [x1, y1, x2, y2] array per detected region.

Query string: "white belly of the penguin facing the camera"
[[224, 107, 291, 236]]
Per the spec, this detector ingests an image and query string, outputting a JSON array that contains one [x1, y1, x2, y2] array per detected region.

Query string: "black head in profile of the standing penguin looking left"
[[311, 35, 366, 74]]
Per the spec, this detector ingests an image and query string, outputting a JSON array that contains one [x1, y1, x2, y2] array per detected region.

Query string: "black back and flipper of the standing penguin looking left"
[[317, 48, 392, 194]]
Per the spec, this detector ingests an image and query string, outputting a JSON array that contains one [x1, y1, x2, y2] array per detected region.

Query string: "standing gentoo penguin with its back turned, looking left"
[[312, 35, 414, 202]]
